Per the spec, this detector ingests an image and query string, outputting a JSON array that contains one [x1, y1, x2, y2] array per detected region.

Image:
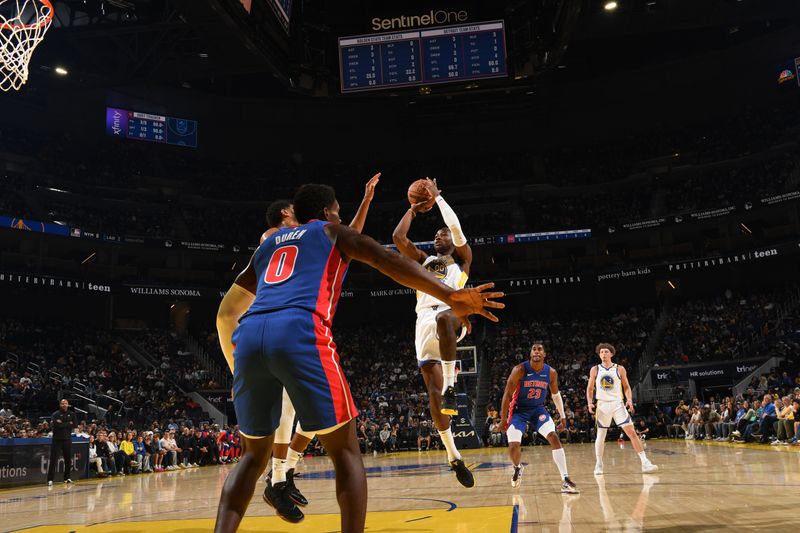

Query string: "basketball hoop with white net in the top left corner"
[[0, 0, 55, 92]]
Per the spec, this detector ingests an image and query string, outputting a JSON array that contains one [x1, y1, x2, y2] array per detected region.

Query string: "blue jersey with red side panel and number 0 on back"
[[242, 220, 348, 328]]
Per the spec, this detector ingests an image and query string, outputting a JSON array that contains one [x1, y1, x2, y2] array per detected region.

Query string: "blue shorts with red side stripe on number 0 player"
[[233, 308, 358, 437]]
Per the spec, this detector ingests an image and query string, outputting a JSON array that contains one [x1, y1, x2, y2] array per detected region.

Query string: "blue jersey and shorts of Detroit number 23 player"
[[506, 361, 556, 442]]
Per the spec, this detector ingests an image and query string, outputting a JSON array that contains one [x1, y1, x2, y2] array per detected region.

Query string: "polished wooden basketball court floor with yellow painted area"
[[0, 440, 800, 533]]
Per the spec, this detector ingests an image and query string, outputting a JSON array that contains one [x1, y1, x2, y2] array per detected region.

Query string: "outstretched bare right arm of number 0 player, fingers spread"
[[327, 224, 505, 329]]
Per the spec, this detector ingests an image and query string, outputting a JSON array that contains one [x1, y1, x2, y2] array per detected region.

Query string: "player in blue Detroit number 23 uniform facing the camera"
[[501, 343, 578, 494]]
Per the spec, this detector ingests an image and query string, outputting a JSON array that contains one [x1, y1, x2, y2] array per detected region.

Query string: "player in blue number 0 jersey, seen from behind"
[[209, 185, 504, 533]]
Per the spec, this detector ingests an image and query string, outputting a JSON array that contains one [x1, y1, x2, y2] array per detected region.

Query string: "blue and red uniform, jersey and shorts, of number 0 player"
[[233, 220, 358, 437]]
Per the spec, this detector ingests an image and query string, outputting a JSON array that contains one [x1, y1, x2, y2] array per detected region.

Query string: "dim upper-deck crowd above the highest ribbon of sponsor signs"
[[0, 107, 800, 246]]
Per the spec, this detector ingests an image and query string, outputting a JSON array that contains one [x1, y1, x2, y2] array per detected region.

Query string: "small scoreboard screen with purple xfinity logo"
[[106, 107, 197, 148]]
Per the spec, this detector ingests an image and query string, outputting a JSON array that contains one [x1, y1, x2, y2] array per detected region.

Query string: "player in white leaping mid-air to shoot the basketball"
[[392, 179, 475, 487]]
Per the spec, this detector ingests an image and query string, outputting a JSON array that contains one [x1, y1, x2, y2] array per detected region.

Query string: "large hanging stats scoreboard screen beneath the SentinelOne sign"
[[339, 20, 508, 93]]
